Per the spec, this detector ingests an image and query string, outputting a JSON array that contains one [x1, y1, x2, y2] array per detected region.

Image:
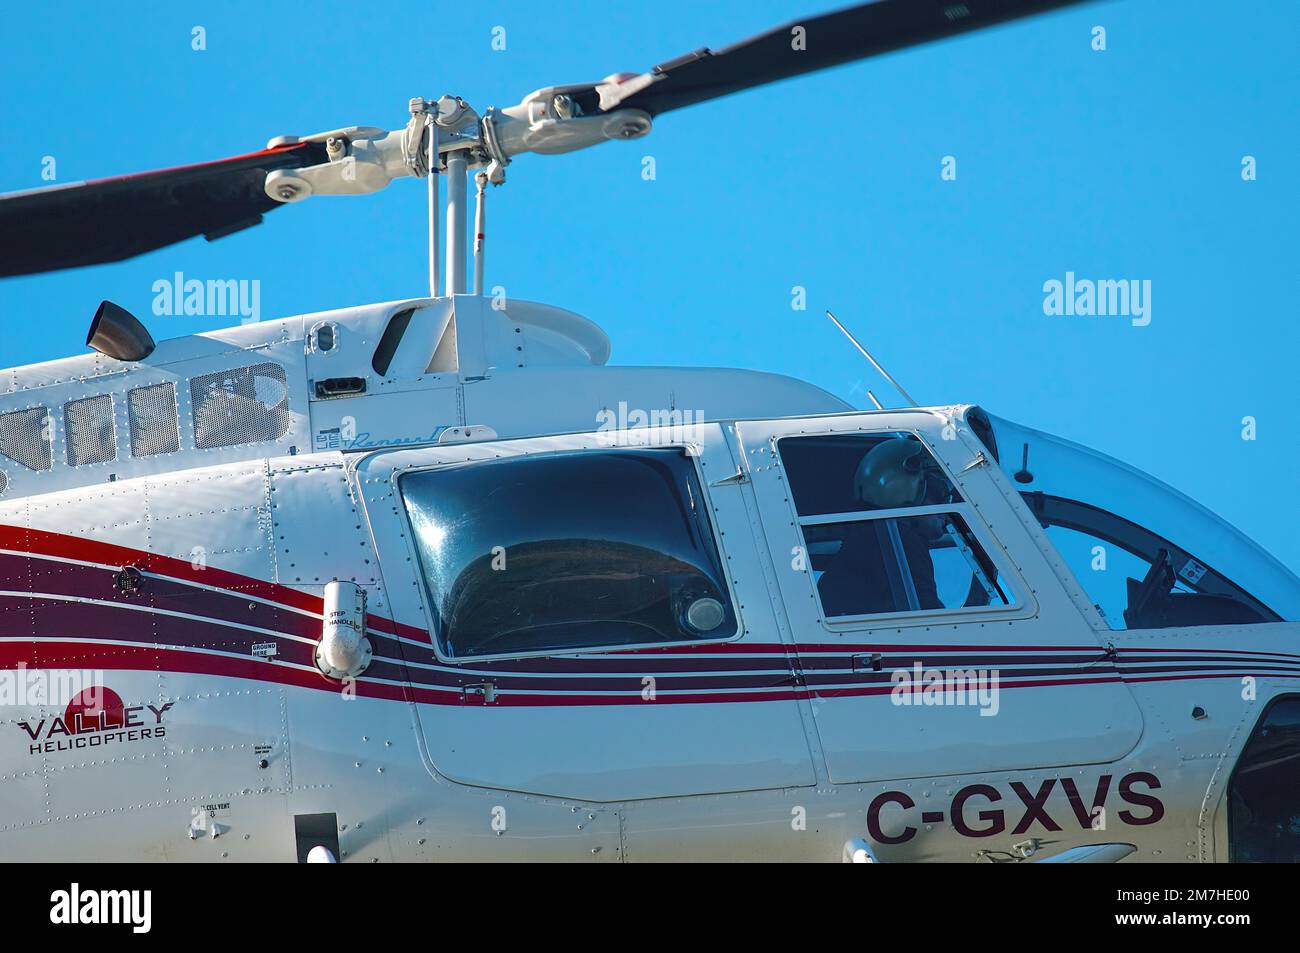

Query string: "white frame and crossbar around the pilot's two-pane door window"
[[771, 426, 1035, 624]]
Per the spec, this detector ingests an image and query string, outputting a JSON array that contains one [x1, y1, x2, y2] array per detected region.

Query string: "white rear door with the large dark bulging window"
[[358, 424, 815, 801]]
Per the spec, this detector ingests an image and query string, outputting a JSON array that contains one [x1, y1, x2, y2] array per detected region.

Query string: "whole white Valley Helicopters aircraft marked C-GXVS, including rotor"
[[0, 0, 1300, 862]]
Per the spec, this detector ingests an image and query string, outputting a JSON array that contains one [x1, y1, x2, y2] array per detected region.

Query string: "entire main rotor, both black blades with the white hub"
[[0, 0, 1083, 280]]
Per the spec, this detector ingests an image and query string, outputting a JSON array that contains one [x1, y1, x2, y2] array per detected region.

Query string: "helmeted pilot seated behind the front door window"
[[818, 437, 952, 616]]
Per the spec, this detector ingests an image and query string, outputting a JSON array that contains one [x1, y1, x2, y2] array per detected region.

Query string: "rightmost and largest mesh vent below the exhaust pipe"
[[190, 364, 293, 450]]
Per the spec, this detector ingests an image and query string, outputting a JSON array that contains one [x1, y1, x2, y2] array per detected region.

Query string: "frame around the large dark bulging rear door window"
[[390, 441, 745, 657]]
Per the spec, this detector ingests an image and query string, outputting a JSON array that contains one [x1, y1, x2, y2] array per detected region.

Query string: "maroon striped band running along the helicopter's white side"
[[0, 554, 1300, 699]]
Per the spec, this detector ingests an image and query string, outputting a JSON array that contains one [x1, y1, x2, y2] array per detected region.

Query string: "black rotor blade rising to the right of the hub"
[[601, 0, 1084, 116]]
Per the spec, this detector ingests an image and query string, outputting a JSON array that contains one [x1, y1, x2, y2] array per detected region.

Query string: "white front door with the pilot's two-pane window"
[[737, 411, 1143, 783]]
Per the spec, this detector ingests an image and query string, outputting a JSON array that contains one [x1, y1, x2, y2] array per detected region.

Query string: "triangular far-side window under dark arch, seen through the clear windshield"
[[1022, 491, 1281, 629]]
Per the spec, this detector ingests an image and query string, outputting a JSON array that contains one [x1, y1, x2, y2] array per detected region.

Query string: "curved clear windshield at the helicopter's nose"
[[969, 410, 1300, 628]]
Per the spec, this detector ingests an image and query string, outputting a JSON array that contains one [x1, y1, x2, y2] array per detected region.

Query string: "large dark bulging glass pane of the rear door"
[[400, 449, 737, 658]]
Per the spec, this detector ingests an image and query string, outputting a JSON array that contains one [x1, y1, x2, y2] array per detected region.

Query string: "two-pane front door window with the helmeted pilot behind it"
[[777, 433, 1013, 619]]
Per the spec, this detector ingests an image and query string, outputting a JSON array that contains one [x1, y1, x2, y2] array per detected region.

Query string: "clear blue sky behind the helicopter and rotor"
[[0, 0, 1300, 571]]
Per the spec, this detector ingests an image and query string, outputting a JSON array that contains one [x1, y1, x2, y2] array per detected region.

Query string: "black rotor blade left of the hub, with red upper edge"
[[0, 142, 326, 277]]
